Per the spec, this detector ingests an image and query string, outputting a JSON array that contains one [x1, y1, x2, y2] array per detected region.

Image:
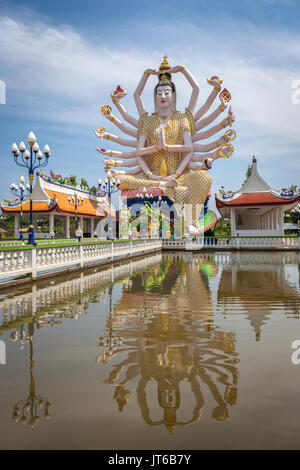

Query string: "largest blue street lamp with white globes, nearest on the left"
[[11, 131, 51, 245]]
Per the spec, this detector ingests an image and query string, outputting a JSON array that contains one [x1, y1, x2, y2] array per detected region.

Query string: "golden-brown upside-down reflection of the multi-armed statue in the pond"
[[96, 255, 239, 433]]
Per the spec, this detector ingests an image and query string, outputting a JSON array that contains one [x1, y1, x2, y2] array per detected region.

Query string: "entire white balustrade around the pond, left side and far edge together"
[[0, 237, 300, 285]]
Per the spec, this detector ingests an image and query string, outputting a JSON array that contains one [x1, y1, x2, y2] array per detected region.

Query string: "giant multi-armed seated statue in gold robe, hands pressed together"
[[95, 56, 236, 235]]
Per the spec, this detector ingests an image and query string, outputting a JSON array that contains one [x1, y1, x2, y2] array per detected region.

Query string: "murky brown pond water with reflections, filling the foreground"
[[0, 252, 300, 449]]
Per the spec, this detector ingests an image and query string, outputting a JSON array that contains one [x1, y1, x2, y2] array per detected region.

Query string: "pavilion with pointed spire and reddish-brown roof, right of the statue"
[[215, 157, 300, 236]]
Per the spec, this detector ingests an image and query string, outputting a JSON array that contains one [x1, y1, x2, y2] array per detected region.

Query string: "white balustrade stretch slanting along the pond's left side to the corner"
[[0, 240, 162, 282]]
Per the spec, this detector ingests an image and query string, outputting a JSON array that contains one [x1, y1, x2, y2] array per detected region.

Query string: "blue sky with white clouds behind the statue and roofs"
[[0, 0, 300, 213]]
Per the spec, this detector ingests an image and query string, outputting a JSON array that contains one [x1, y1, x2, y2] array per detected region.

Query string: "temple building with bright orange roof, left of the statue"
[[1, 172, 108, 238]]
